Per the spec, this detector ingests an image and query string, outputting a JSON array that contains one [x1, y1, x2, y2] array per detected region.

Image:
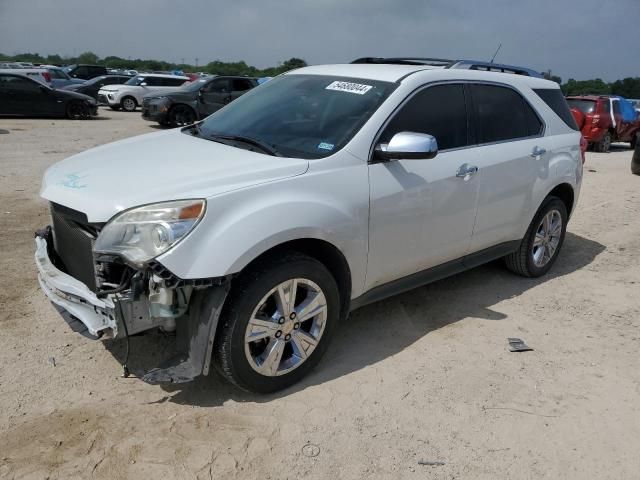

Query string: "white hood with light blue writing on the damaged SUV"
[[40, 129, 309, 222]]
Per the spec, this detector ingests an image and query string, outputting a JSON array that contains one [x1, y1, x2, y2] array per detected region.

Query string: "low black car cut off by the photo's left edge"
[[0, 73, 98, 119]]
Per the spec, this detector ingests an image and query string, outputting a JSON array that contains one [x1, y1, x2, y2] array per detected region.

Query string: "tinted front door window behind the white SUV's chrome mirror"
[[380, 84, 469, 150]]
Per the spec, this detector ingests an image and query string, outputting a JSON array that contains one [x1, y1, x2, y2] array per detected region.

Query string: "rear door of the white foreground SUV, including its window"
[[469, 83, 554, 253]]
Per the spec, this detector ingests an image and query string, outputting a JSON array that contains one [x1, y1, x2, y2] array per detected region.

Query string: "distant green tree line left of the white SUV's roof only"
[[0, 52, 307, 77]]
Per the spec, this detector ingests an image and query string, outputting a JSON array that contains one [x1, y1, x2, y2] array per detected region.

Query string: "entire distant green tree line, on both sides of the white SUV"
[[0, 52, 640, 98]]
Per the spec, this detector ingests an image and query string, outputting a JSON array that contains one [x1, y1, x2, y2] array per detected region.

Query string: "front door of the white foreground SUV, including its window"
[[366, 84, 478, 289]]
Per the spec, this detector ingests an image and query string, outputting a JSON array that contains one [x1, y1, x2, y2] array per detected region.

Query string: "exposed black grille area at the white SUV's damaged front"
[[51, 203, 99, 291]]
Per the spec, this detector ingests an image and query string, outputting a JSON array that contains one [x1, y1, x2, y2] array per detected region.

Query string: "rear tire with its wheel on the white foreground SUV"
[[505, 196, 568, 277]]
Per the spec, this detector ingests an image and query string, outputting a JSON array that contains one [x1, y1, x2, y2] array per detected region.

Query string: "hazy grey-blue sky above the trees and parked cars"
[[0, 0, 640, 81]]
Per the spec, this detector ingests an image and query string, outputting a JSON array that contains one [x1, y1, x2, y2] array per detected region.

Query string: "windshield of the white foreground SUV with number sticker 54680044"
[[193, 74, 396, 159]]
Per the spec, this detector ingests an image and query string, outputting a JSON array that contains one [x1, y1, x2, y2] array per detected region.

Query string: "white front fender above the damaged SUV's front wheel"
[[156, 164, 369, 295]]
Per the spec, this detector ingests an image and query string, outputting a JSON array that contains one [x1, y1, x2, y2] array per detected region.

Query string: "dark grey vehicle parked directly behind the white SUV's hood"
[[142, 76, 258, 127]]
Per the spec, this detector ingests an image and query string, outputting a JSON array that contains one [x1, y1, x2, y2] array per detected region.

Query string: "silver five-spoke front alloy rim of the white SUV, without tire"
[[245, 278, 327, 377]]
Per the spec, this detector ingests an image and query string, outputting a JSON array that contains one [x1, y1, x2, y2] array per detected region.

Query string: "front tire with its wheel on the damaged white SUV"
[[214, 252, 340, 393]]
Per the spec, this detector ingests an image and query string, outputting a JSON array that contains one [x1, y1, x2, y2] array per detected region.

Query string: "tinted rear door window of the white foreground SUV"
[[470, 85, 542, 143]]
